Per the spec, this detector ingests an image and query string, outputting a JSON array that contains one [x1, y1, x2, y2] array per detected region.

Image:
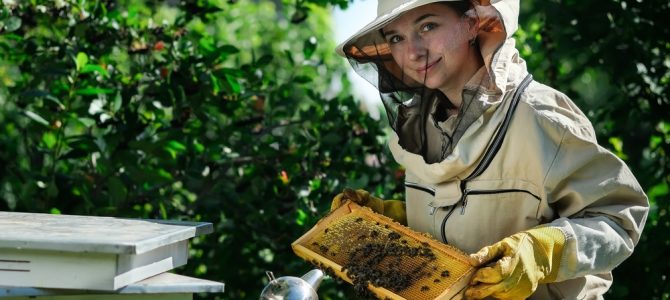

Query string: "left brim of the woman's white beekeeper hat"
[[335, 0, 459, 59]]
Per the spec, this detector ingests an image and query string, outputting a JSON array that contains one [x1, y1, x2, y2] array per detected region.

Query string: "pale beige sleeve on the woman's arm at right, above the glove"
[[545, 123, 649, 281]]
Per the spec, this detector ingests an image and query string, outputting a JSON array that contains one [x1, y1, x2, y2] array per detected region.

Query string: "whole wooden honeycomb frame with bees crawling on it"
[[292, 202, 475, 299]]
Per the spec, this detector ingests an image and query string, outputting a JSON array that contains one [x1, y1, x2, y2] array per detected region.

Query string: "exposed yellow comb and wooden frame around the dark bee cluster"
[[291, 201, 475, 300]]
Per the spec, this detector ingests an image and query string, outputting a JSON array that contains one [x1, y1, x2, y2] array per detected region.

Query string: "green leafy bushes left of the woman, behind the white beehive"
[[0, 0, 397, 299]]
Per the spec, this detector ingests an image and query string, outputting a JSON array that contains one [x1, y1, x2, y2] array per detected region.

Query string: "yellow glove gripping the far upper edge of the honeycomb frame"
[[330, 189, 407, 225]]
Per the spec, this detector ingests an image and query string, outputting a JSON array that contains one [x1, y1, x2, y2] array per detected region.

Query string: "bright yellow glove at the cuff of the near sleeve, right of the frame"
[[465, 226, 565, 299]]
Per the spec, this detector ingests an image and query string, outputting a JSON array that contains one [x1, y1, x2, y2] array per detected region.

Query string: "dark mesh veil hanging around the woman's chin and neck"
[[344, 8, 492, 163]]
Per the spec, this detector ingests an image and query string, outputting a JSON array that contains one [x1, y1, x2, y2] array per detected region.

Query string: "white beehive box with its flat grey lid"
[[0, 212, 213, 291]]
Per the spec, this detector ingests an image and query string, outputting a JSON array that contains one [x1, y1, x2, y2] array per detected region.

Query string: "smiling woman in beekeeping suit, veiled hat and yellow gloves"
[[332, 0, 648, 299]]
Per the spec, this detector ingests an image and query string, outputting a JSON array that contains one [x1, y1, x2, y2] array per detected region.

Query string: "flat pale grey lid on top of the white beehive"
[[0, 212, 213, 254]]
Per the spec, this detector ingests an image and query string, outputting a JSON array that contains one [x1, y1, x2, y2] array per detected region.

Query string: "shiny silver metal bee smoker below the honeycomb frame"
[[260, 269, 323, 300]]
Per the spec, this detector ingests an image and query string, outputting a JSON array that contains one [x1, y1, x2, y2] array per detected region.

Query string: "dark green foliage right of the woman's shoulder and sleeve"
[[517, 0, 670, 299]]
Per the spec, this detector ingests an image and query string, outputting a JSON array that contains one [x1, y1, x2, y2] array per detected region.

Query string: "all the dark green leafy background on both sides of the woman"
[[0, 0, 670, 299]]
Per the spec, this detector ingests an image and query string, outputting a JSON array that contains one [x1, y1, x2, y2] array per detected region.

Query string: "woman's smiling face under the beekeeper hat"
[[383, 3, 475, 91]]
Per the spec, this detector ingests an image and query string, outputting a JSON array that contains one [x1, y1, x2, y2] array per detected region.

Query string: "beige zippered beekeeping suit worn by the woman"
[[380, 0, 648, 299]]
